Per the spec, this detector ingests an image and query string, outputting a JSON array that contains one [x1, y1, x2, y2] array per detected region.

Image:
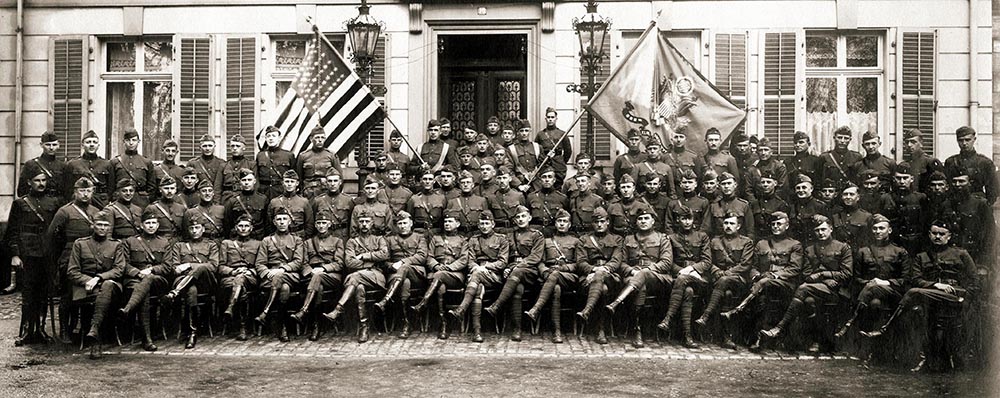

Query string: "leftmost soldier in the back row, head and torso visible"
[[17, 131, 74, 203]]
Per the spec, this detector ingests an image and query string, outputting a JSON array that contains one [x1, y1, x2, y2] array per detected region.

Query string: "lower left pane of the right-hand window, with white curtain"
[[806, 77, 837, 151]]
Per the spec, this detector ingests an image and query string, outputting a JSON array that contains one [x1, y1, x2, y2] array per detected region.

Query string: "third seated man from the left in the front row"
[[157, 215, 219, 349]]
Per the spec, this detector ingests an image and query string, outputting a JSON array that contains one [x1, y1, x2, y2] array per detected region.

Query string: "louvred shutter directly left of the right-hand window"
[[762, 32, 795, 155]]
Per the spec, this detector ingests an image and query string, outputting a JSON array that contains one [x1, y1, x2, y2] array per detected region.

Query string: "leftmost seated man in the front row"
[[66, 211, 126, 359]]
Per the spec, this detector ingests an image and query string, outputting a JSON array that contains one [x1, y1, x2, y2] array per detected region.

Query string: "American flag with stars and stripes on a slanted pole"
[[256, 32, 385, 159]]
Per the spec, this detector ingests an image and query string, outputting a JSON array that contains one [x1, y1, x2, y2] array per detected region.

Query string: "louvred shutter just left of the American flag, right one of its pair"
[[226, 37, 257, 158]]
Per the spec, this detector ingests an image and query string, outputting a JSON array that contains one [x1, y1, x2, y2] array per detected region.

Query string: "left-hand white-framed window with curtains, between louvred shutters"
[[101, 37, 174, 160]]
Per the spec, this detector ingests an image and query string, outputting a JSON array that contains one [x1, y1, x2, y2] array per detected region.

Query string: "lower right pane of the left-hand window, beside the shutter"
[[142, 82, 173, 160]]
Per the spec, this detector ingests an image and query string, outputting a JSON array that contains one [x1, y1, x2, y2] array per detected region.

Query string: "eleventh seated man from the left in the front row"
[[485, 204, 555, 341]]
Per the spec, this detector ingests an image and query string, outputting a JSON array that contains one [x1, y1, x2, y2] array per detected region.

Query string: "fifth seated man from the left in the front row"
[[254, 207, 303, 342]]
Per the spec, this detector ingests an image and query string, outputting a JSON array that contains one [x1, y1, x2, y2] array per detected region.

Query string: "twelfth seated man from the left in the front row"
[[524, 209, 580, 344]]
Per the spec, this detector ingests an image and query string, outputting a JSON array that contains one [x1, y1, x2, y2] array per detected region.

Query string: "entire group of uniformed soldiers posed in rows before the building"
[[8, 116, 997, 372]]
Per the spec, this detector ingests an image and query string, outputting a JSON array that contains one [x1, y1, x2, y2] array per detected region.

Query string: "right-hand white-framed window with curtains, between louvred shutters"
[[805, 32, 886, 151]]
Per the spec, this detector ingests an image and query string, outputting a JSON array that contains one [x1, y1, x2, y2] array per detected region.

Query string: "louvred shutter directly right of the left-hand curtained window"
[[180, 38, 212, 160]]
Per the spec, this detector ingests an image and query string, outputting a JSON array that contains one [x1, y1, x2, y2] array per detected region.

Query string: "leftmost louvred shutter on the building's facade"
[[49, 39, 86, 158]]
